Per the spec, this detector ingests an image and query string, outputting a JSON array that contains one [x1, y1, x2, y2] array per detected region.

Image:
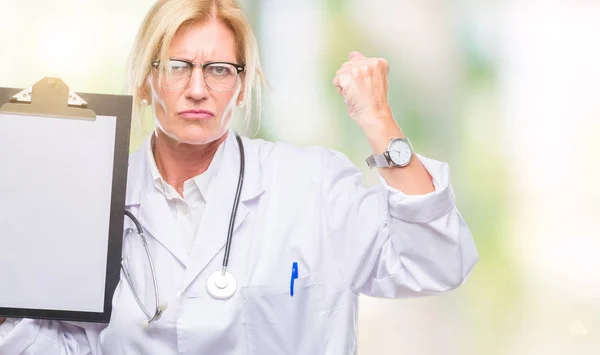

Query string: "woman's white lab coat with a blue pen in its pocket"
[[0, 132, 478, 355]]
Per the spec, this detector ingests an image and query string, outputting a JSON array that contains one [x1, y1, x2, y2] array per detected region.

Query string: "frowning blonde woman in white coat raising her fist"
[[0, 0, 477, 355]]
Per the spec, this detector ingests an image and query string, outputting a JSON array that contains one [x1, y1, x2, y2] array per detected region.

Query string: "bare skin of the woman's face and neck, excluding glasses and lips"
[[143, 19, 242, 196]]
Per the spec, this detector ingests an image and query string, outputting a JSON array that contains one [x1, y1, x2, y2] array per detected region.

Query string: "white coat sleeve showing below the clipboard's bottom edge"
[[0, 319, 103, 355]]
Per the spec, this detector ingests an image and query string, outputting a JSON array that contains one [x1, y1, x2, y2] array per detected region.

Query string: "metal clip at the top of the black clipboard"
[[0, 77, 96, 121]]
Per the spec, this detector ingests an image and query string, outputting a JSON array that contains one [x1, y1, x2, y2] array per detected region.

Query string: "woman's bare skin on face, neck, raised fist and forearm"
[[0, 12, 435, 334]]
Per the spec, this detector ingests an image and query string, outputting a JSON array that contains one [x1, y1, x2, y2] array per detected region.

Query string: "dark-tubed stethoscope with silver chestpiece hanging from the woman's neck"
[[121, 134, 246, 327]]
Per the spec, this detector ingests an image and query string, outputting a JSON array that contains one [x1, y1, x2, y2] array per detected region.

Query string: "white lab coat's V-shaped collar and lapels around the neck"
[[126, 130, 264, 268]]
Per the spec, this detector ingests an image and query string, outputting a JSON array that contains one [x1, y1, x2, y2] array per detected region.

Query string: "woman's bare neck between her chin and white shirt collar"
[[153, 130, 227, 197]]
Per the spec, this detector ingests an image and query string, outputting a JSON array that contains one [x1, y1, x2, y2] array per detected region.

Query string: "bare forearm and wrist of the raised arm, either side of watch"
[[361, 109, 435, 195]]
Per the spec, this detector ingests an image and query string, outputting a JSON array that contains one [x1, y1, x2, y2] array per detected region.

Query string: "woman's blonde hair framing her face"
[[128, 0, 264, 131]]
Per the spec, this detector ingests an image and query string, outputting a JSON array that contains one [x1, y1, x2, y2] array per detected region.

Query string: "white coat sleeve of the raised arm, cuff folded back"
[[322, 152, 478, 298]]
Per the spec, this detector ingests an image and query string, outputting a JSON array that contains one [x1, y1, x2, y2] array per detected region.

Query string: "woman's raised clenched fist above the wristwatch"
[[333, 52, 391, 126]]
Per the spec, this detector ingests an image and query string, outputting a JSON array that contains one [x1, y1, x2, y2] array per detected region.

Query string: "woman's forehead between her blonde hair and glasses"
[[169, 19, 236, 62]]
